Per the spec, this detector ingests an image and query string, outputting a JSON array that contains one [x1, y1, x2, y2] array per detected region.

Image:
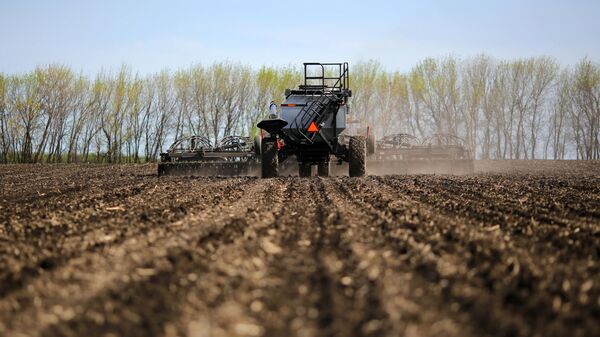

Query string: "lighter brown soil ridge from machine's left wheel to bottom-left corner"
[[0, 179, 264, 331]]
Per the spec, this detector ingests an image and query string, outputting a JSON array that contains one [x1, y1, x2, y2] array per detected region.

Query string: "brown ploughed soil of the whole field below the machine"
[[0, 162, 600, 337]]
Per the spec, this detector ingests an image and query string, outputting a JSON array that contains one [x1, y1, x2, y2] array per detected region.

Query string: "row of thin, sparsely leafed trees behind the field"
[[0, 55, 600, 163]]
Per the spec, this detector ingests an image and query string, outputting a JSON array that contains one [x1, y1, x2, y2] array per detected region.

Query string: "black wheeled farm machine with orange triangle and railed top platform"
[[257, 63, 367, 178]]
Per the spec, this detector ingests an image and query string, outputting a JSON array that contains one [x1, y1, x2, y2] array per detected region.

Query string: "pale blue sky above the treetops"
[[0, 0, 600, 73]]
